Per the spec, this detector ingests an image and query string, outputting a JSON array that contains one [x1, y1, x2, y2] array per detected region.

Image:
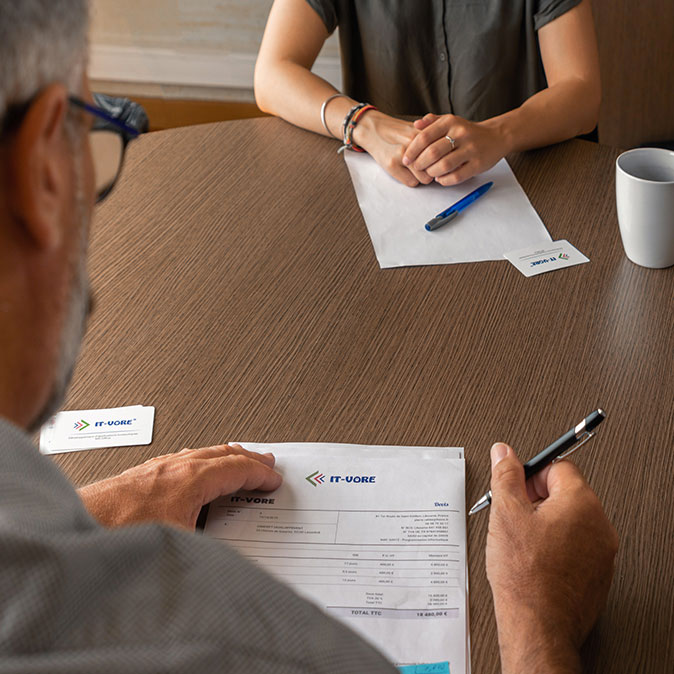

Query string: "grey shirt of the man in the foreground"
[[0, 419, 395, 674]]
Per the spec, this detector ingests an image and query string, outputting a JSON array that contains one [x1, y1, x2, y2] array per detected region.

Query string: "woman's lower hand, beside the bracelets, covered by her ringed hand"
[[353, 110, 433, 187]]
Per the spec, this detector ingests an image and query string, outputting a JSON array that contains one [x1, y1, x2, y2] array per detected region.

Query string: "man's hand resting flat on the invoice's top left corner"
[[79, 445, 281, 529]]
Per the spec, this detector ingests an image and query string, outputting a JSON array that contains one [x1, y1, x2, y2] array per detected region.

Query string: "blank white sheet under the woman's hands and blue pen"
[[344, 152, 552, 268]]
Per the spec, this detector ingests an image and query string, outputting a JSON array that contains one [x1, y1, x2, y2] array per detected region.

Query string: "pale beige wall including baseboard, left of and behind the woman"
[[90, 0, 341, 101]]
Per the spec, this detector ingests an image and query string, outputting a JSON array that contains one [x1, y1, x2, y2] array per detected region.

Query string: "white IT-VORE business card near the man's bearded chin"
[[40, 405, 154, 454]]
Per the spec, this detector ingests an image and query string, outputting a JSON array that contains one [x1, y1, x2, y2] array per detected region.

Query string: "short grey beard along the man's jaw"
[[29, 162, 92, 432]]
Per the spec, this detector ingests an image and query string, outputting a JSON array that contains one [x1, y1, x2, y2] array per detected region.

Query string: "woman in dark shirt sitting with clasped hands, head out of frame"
[[255, 0, 601, 187]]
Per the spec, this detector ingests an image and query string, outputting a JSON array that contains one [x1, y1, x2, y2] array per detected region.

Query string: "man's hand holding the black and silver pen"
[[486, 443, 618, 674]]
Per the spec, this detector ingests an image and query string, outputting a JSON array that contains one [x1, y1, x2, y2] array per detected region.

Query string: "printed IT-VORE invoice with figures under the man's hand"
[[204, 442, 470, 674]]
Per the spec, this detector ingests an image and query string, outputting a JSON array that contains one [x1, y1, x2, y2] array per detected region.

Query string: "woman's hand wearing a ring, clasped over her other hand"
[[402, 113, 508, 185]]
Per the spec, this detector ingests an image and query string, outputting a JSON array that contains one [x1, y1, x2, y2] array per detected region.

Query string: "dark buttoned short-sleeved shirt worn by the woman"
[[307, 0, 581, 121]]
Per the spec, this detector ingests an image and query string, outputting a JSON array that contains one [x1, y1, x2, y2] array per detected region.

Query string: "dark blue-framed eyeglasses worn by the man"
[[68, 96, 140, 204]]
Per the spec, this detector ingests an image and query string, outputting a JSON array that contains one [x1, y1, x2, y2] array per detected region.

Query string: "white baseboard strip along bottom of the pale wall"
[[89, 45, 341, 96]]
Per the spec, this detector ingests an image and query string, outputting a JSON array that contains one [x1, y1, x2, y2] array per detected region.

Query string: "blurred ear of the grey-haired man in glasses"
[[8, 84, 72, 250]]
